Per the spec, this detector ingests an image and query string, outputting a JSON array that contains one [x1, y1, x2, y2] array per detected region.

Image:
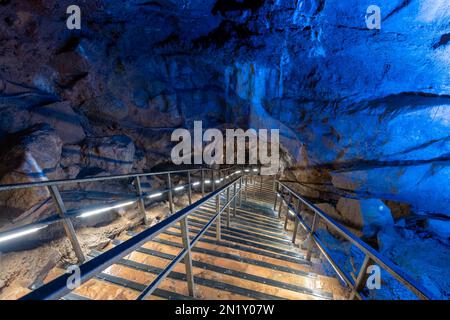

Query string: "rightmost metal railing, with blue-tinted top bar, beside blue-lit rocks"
[[274, 180, 433, 300]]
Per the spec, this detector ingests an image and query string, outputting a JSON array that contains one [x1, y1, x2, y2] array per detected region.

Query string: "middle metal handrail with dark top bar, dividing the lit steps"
[[21, 175, 242, 300]]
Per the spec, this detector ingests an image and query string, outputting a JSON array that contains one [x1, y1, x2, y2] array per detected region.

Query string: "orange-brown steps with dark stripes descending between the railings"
[[46, 182, 346, 300]]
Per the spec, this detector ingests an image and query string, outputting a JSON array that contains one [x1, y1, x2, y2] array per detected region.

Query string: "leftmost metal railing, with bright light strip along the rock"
[[0, 167, 241, 263]]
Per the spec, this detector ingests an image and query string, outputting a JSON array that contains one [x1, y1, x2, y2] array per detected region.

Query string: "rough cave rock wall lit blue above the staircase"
[[0, 0, 450, 236]]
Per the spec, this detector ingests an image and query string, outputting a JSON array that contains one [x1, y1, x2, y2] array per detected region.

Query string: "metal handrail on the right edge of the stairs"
[[275, 180, 434, 300]]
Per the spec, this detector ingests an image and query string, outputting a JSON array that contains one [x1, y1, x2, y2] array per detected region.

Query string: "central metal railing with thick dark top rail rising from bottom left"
[[21, 175, 243, 300]]
